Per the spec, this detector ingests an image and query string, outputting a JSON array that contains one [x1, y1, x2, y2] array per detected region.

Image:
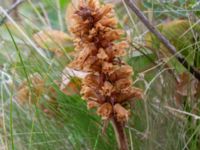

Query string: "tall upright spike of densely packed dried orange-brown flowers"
[[69, 0, 142, 122]]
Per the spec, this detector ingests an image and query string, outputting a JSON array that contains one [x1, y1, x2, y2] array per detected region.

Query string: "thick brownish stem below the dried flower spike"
[[112, 117, 128, 150]]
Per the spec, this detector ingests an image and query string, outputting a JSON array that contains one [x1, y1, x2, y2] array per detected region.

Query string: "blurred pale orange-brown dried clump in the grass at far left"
[[16, 73, 58, 116]]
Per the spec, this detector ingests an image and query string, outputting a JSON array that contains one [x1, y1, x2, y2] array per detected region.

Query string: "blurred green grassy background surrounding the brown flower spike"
[[0, 0, 200, 150]]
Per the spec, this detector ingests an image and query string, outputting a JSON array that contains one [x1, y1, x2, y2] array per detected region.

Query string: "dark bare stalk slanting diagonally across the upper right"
[[124, 0, 200, 81]]
